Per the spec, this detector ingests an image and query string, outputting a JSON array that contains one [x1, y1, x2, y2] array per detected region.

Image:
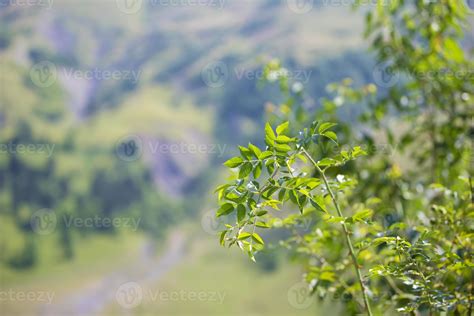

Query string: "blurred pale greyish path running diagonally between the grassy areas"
[[38, 231, 185, 316]]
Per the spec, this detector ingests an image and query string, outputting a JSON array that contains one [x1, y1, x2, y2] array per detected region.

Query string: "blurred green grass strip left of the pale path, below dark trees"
[[0, 216, 144, 315]]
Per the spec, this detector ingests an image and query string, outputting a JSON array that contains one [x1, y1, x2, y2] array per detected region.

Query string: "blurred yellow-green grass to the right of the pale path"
[[104, 222, 338, 316]]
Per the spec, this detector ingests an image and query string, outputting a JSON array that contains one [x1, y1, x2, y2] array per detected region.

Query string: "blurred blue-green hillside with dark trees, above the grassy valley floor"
[[0, 0, 474, 266]]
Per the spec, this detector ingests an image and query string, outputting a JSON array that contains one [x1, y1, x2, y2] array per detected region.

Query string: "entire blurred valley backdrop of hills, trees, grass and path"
[[0, 0, 474, 315]]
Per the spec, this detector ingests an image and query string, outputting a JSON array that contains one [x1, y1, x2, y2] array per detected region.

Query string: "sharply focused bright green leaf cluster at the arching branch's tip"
[[216, 122, 364, 260]]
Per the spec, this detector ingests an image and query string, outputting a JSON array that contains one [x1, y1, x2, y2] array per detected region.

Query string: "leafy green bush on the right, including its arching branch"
[[218, 0, 474, 315]]
